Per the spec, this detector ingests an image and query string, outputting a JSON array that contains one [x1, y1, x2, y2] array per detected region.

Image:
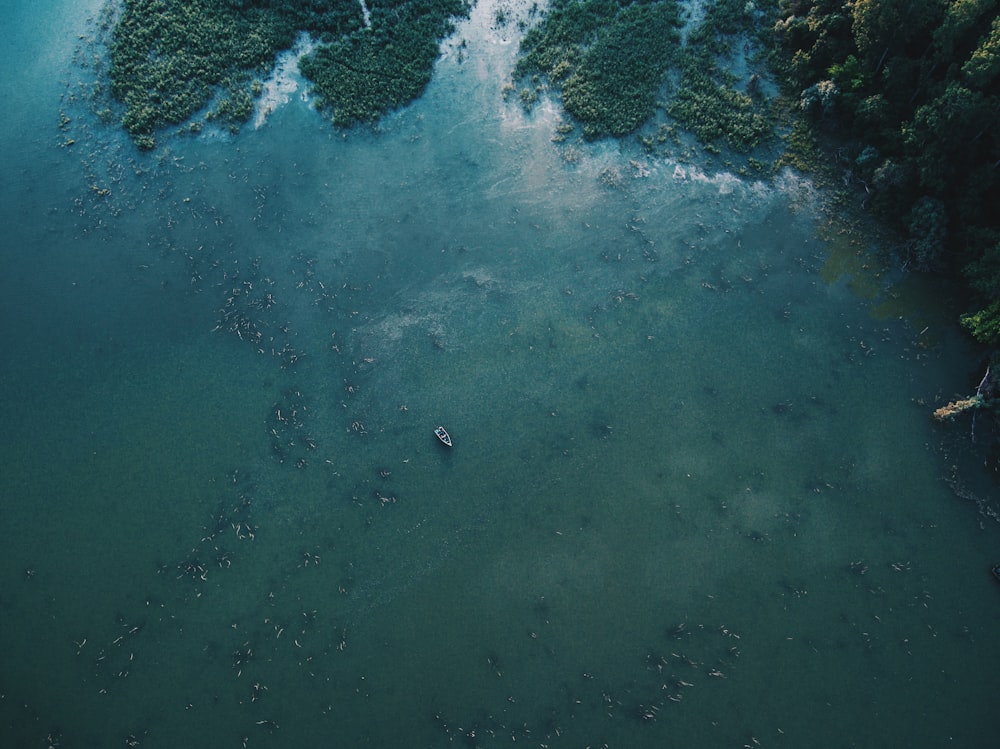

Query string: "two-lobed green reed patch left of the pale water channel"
[[111, 0, 467, 148]]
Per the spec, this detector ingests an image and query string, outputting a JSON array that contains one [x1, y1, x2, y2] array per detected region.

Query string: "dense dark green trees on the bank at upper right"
[[774, 0, 1000, 342]]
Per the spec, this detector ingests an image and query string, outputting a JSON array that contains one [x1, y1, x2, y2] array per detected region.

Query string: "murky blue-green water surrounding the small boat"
[[0, 3, 1000, 747]]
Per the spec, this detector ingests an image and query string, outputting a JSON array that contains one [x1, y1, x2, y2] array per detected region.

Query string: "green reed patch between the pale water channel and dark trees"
[[514, 0, 772, 152]]
